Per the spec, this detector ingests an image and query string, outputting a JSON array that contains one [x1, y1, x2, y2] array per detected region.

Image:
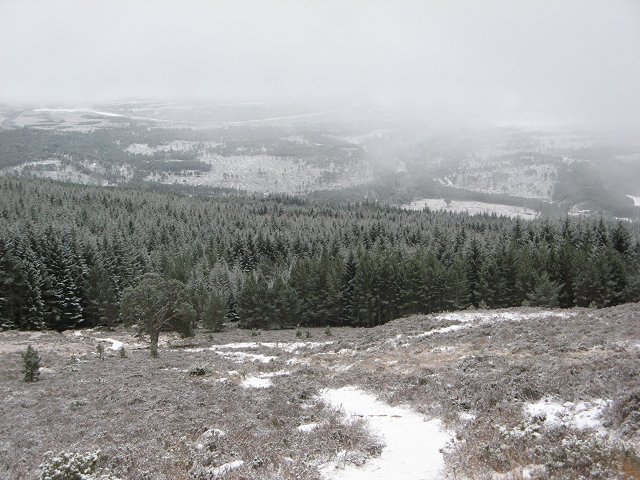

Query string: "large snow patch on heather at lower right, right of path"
[[523, 398, 611, 433]]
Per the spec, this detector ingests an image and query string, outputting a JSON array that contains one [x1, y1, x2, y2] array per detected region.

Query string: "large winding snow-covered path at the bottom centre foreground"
[[320, 387, 451, 480]]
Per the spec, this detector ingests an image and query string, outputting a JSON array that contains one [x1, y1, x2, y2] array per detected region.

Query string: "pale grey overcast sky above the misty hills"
[[0, 0, 640, 125]]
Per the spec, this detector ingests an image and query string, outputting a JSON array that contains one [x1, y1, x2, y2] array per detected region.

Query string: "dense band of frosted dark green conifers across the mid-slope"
[[0, 178, 640, 332]]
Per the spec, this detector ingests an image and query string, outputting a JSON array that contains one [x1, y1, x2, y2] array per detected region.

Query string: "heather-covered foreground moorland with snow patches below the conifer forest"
[[0, 304, 640, 480]]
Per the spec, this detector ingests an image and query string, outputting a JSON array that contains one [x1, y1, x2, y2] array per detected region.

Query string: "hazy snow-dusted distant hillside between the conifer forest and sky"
[[0, 101, 640, 219]]
